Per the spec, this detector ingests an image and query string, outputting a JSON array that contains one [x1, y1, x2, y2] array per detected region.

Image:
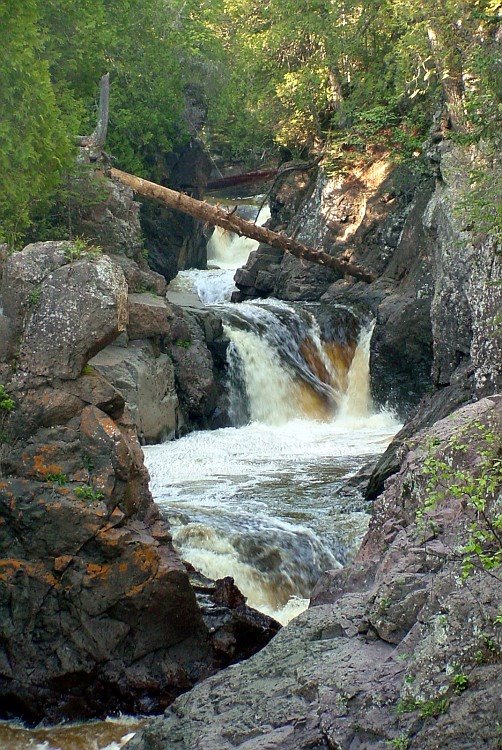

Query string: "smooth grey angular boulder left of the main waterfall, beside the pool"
[[89, 342, 182, 443]]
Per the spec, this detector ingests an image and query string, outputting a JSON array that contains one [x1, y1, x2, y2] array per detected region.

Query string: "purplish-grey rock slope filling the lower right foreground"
[[131, 397, 502, 750]]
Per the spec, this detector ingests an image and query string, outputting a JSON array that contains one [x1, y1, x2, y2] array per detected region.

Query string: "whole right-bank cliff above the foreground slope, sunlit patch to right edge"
[[236, 142, 500, 420]]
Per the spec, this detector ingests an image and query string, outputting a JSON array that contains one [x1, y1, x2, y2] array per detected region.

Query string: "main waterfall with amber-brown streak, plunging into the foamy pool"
[[221, 300, 373, 424]]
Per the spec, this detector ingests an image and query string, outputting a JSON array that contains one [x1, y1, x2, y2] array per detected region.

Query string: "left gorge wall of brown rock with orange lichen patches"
[[0, 173, 279, 722]]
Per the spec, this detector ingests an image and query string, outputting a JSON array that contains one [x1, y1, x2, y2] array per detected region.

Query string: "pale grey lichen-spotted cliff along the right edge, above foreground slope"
[[367, 144, 502, 497]]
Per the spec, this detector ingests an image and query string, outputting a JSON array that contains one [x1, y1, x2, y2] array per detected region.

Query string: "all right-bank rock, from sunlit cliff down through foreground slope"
[[131, 144, 502, 750]]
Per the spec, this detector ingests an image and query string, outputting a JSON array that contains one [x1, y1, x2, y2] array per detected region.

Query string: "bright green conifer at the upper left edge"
[[0, 0, 75, 245]]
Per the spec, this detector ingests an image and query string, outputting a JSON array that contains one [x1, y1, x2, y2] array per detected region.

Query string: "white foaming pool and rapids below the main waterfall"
[[145, 331, 399, 623]]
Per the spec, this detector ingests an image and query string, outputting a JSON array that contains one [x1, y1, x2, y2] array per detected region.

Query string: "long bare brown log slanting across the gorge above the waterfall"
[[110, 168, 376, 282]]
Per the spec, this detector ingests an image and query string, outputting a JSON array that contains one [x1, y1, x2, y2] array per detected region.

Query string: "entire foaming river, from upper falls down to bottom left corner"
[[0, 198, 400, 750]]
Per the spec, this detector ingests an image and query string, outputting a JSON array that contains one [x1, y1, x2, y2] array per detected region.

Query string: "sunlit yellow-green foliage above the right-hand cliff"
[[209, 0, 502, 163]]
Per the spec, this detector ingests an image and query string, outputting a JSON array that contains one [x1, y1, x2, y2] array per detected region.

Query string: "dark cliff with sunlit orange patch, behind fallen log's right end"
[[235, 157, 434, 417]]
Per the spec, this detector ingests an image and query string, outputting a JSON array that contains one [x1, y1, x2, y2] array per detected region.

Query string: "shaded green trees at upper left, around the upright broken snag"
[[0, 0, 224, 245]]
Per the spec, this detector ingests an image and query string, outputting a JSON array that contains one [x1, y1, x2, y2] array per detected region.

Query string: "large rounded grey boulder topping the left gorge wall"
[[18, 251, 128, 379]]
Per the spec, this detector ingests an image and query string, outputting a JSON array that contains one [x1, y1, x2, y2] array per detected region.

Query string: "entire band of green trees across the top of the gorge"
[[0, 0, 502, 245]]
